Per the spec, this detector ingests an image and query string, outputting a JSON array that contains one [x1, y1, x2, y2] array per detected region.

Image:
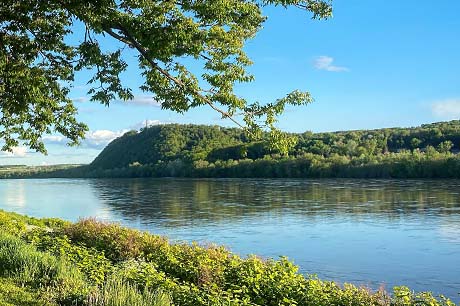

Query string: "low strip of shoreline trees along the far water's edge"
[[72, 151, 460, 178]]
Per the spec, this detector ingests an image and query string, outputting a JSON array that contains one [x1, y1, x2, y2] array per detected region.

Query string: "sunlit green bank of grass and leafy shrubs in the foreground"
[[0, 211, 454, 306]]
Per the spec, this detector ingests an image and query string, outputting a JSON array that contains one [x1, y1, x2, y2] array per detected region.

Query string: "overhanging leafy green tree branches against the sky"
[[0, 0, 332, 152]]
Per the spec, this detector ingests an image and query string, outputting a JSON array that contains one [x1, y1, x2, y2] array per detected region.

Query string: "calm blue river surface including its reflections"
[[0, 179, 460, 303]]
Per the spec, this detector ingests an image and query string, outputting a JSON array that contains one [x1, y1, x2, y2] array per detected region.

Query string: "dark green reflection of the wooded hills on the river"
[[91, 179, 460, 226]]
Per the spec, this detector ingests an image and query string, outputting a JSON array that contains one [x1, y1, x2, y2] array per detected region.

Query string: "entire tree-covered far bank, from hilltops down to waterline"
[[82, 120, 460, 178]]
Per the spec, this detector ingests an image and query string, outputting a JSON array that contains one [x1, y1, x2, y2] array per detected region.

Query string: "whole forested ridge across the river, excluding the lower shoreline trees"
[[91, 120, 460, 169]]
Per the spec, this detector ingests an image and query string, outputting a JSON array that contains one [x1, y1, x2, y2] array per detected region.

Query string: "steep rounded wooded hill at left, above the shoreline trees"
[[91, 124, 247, 169]]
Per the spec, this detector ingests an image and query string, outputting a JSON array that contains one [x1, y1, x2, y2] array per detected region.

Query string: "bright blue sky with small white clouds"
[[0, 0, 460, 165]]
